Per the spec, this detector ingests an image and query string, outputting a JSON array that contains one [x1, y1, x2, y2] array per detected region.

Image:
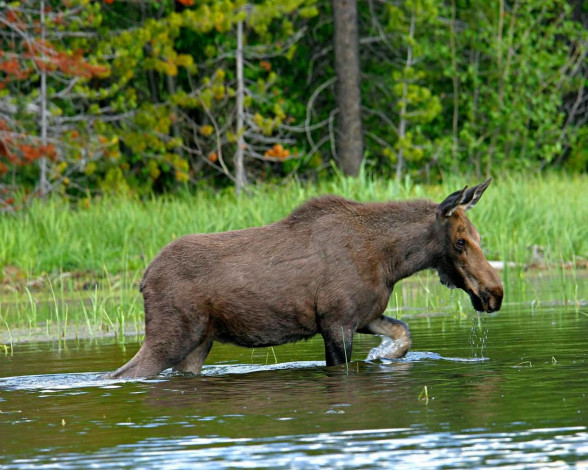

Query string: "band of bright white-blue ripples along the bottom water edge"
[[4, 426, 588, 470]]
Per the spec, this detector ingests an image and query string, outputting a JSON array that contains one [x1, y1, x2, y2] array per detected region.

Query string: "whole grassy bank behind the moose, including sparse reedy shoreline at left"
[[0, 175, 588, 341]]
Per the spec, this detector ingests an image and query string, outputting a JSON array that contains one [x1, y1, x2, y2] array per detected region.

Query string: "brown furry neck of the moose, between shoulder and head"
[[372, 201, 442, 285]]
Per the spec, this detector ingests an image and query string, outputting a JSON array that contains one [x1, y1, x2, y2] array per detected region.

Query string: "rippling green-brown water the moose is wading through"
[[0, 305, 588, 470]]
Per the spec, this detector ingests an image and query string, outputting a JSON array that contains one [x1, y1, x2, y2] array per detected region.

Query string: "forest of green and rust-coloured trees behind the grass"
[[0, 0, 588, 211]]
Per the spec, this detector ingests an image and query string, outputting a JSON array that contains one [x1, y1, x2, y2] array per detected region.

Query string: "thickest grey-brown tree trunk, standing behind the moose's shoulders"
[[331, 0, 363, 176]]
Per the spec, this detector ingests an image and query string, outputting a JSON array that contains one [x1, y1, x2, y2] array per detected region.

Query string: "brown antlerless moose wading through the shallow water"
[[110, 179, 503, 378]]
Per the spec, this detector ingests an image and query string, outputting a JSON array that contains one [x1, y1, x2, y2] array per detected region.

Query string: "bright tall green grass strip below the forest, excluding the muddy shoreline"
[[0, 176, 588, 277]]
